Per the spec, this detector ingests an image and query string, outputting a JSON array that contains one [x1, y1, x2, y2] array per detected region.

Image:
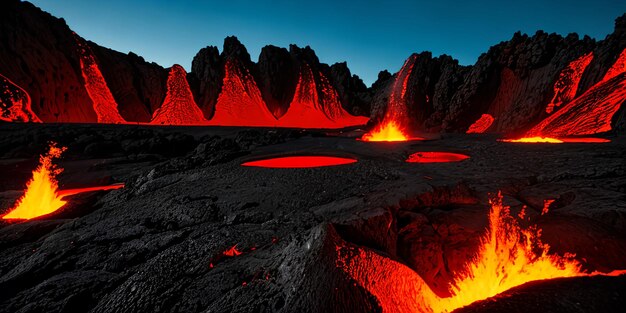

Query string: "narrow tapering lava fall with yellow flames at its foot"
[[361, 55, 417, 141]]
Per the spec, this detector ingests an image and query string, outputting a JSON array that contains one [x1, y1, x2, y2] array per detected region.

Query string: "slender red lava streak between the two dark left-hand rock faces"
[[76, 38, 126, 124]]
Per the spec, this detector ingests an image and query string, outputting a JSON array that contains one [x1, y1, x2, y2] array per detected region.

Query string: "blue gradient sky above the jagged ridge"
[[32, 0, 626, 85]]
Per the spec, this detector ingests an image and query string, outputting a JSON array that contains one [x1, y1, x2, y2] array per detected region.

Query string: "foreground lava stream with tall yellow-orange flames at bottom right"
[[337, 194, 625, 313]]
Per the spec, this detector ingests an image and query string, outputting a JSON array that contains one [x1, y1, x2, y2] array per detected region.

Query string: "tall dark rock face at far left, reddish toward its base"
[[0, 0, 97, 122]]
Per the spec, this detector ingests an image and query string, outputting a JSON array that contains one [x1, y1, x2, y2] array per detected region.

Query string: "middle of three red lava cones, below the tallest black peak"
[[209, 60, 277, 127]]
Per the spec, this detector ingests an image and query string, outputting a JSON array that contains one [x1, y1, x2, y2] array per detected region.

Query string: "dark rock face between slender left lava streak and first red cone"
[[89, 43, 167, 122]]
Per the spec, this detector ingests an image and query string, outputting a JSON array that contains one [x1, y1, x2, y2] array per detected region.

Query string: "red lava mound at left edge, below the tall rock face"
[[0, 74, 41, 123]]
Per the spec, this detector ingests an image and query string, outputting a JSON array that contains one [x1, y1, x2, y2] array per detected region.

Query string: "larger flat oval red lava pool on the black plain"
[[241, 156, 357, 168]]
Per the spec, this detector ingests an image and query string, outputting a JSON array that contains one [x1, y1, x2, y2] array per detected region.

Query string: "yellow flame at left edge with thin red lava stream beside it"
[[2, 143, 124, 219]]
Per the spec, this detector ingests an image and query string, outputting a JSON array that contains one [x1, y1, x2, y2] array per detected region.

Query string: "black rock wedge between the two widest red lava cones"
[[257, 46, 299, 117]]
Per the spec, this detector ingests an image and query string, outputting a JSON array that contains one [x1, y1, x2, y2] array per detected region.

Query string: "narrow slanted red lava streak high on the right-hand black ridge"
[[546, 52, 593, 113]]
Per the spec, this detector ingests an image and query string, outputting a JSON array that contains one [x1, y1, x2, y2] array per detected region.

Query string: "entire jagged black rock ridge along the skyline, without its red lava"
[[0, 0, 626, 134]]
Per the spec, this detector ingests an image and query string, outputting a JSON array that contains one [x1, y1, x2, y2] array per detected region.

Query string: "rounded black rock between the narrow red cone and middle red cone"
[[188, 46, 224, 119]]
